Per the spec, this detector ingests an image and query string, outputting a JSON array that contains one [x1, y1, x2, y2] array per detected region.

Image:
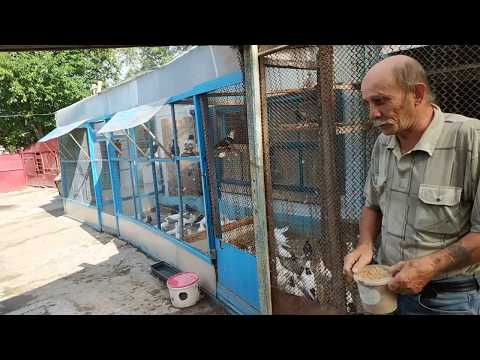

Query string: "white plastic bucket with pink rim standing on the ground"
[[167, 272, 200, 308]]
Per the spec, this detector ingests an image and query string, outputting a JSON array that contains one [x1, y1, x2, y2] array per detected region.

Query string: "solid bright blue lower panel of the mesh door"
[[215, 239, 260, 310]]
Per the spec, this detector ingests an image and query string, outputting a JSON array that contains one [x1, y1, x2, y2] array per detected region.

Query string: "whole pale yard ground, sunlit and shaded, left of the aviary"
[[0, 187, 226, 315]]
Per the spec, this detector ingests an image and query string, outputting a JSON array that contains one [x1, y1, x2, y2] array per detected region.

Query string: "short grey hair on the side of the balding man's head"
[[393, 57, 435, 103]]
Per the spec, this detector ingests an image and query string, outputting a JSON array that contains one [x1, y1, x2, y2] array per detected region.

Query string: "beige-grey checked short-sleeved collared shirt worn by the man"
[[365, 105, 480, 278]]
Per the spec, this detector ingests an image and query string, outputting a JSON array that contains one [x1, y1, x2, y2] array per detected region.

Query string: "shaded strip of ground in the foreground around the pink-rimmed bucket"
[[0, 243, 226, 315]]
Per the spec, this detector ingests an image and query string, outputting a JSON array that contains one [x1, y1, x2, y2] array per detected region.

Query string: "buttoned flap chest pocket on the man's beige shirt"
[[414, 184, 463, 234]]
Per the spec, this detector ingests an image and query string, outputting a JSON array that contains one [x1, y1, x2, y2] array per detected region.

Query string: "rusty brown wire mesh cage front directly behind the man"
[[251, 45, 480, 313]]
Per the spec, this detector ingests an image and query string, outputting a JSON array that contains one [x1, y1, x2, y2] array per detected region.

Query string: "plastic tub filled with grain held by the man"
[[353, 265, 397, 314]]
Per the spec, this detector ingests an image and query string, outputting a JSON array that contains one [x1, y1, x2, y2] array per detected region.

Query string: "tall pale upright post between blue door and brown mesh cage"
[[244, 45, 272, 314]]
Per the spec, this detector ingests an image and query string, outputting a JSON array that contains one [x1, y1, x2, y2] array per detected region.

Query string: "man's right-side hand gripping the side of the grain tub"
[[388, 257, 435, 295]]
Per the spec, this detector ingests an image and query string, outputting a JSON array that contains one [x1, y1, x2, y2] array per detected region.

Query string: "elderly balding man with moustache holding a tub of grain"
[[343, 55, 480, 315]]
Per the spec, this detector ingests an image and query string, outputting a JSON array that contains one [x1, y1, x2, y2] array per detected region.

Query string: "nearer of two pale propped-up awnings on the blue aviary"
[[97, 99, 168, 134]]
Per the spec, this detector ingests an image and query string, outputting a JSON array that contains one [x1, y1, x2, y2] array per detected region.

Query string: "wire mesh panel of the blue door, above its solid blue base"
[[206, 83, 255, 255]]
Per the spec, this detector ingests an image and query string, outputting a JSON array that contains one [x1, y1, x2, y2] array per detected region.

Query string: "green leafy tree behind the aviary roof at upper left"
[[0, 49, 120, 151]]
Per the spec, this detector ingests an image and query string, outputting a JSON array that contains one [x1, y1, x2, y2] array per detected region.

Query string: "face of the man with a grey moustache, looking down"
[[362, 76, 415, 135]]
